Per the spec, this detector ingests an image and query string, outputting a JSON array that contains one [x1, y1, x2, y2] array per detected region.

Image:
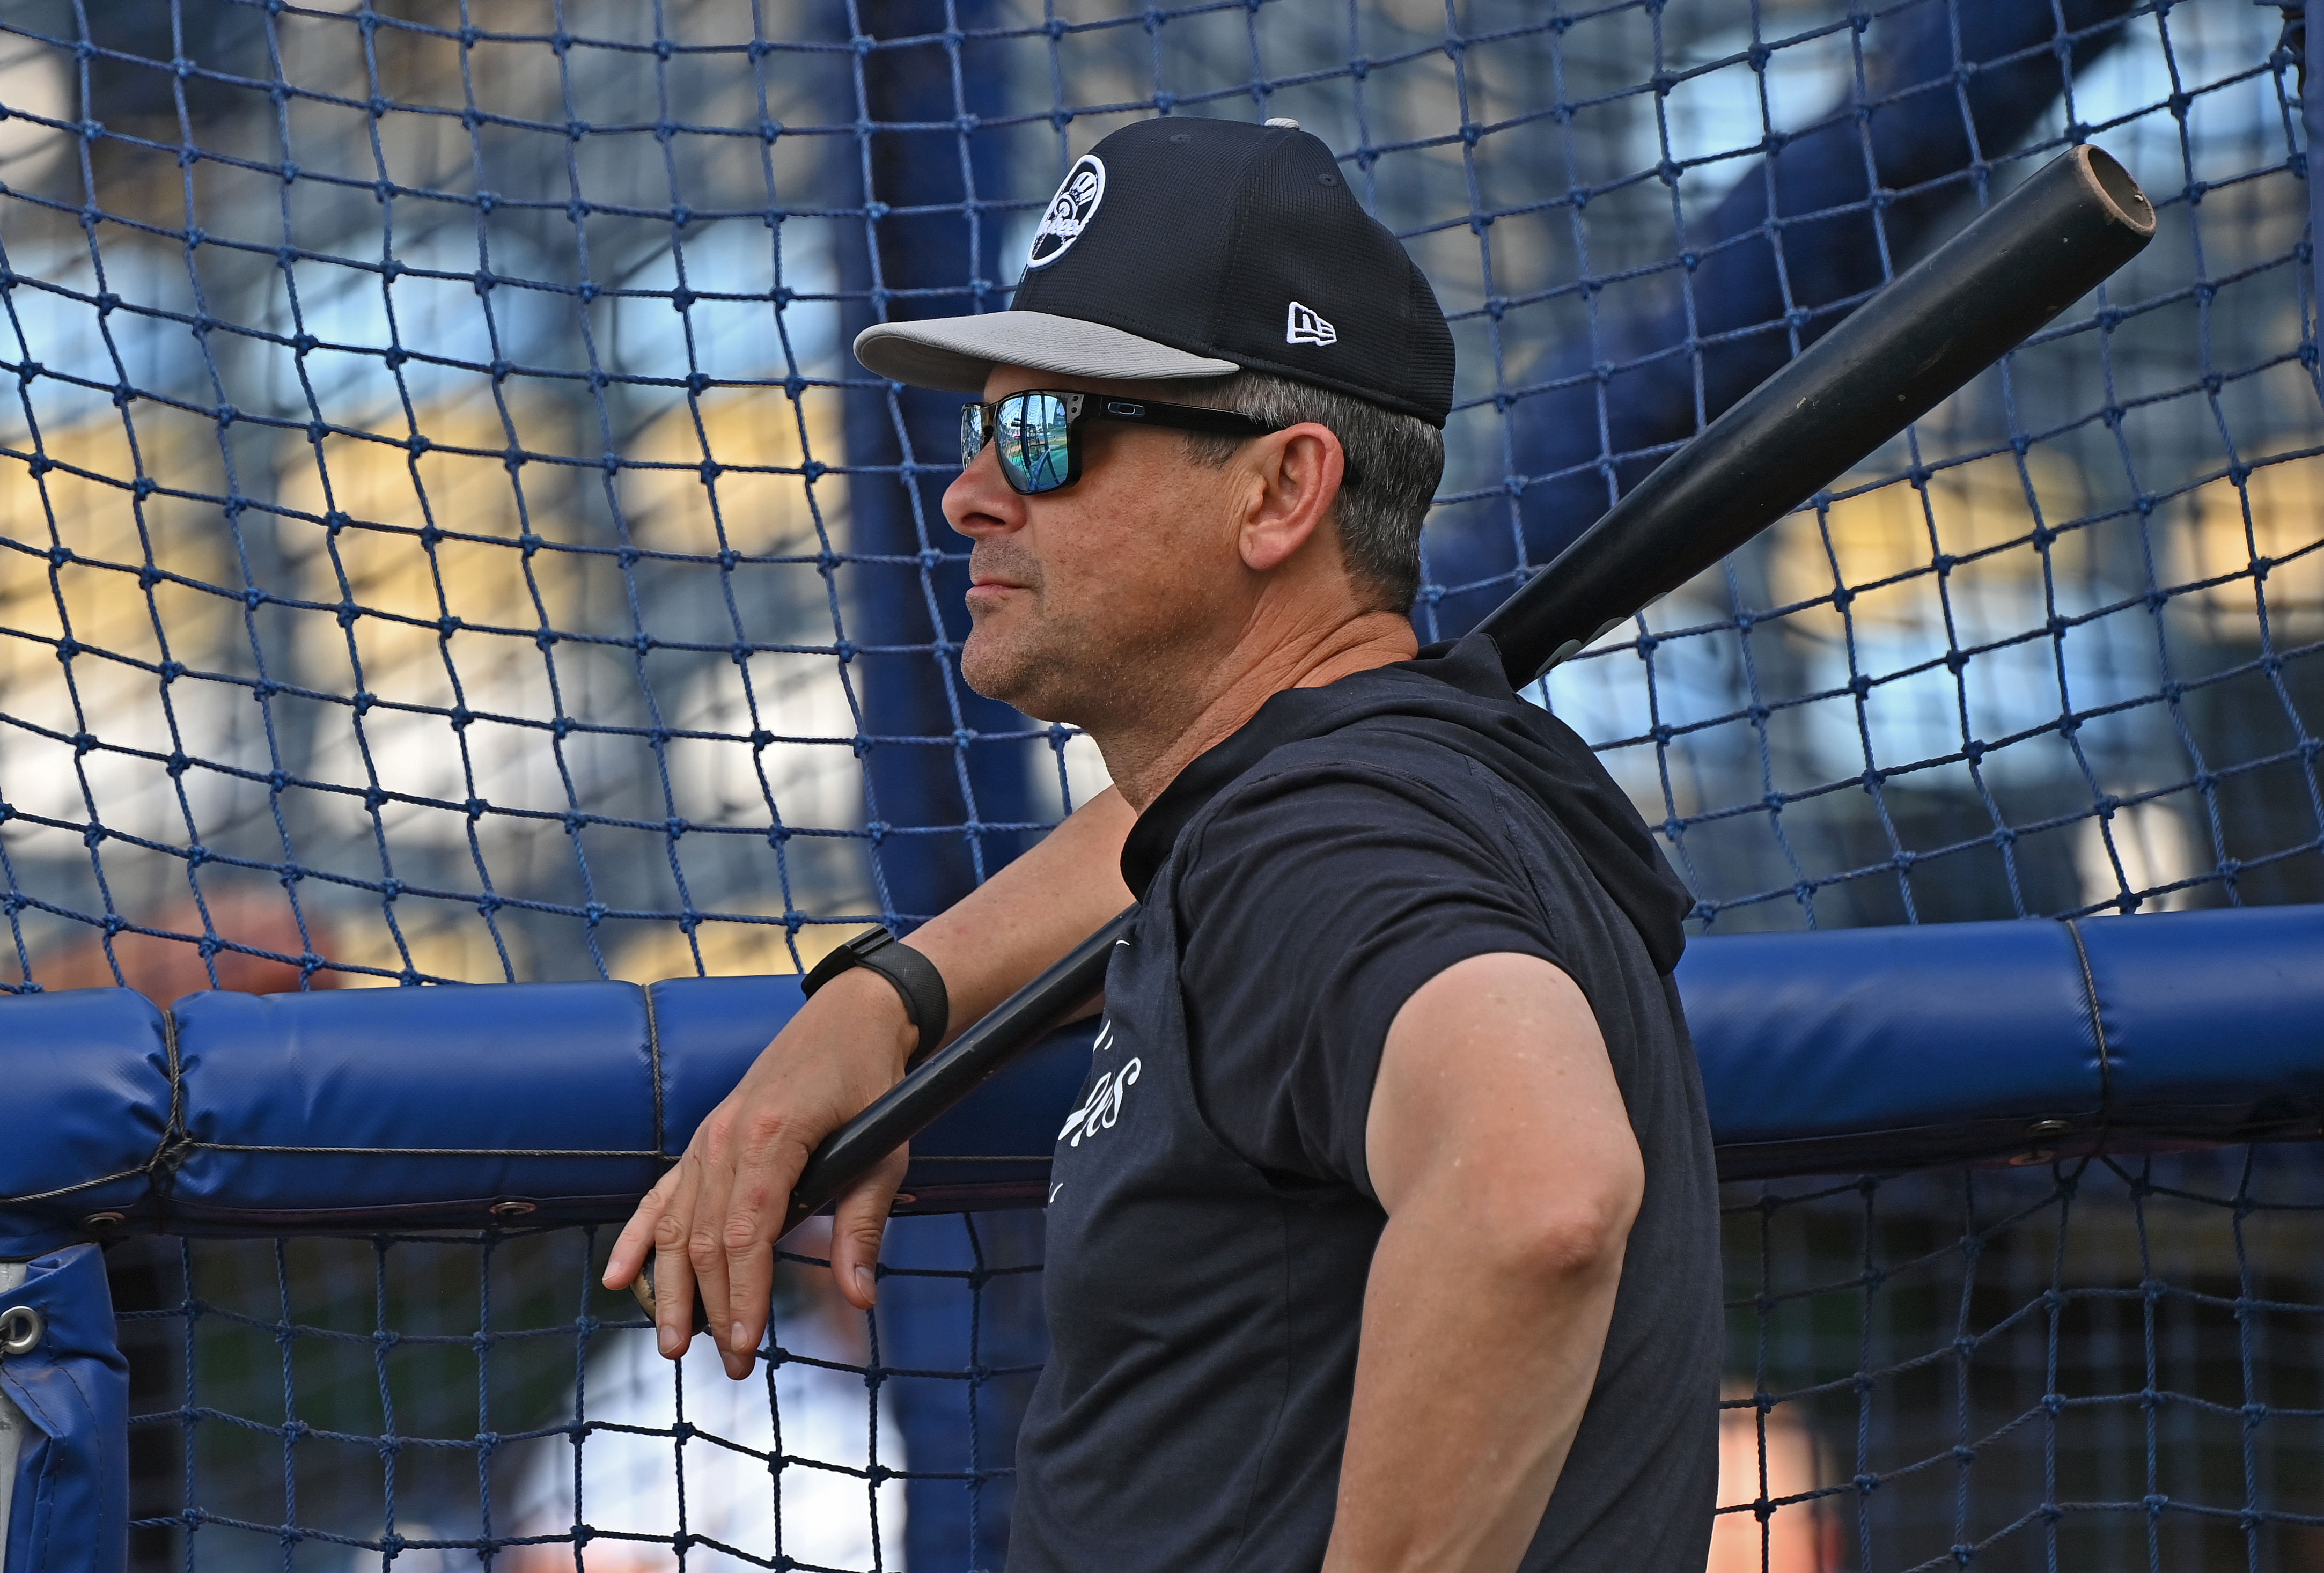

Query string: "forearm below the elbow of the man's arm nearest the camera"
[[1325, 1185, 1627, 1573]]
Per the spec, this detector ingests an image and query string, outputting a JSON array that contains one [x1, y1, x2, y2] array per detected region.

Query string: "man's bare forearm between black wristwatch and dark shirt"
[[911, 788, 1136, 1039]]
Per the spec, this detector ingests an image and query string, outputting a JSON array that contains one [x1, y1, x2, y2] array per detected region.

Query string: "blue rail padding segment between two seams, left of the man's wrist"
[[156, 983, 664, 1231]]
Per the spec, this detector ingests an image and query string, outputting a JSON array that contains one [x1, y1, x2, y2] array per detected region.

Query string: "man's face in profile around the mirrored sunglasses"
[[944, 367, 1244, 727]]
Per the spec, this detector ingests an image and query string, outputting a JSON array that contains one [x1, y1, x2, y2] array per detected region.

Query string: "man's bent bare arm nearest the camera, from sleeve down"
[[1325, 955, 1645, 1573]]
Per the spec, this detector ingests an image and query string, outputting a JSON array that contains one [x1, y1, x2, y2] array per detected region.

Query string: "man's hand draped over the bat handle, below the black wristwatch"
[[604, 969, 920, 1380]]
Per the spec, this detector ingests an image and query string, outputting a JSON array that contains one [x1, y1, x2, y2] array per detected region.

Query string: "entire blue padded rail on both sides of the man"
[[0, 906, 2324, 1257]]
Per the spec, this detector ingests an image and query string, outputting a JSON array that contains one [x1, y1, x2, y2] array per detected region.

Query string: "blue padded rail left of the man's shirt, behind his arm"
[[0, 976, 1090, 1257]]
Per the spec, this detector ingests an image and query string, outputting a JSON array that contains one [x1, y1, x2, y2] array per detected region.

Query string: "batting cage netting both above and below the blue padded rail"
[[0, 0, 2324, 1573]]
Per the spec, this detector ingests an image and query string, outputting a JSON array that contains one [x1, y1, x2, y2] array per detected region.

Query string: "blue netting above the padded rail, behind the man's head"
[[0, 0, 2324, 1566]]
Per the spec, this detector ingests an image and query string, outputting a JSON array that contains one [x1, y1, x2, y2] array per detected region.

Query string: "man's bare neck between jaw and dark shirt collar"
[[1092, 611, 1420, 813]]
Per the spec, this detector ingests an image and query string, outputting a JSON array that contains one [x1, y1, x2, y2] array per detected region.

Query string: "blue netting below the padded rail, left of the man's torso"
[[112, 1213, 1043, 1573]]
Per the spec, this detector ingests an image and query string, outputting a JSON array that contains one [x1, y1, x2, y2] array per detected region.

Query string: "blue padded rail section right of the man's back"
[[1678, 906, 2324, 1178]]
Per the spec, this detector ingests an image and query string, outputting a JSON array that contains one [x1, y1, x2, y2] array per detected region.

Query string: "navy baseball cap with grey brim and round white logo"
[[855, 116, 1453, 425]]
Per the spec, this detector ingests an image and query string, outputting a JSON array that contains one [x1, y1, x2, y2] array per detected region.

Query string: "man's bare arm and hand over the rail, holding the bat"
[[604, 788, 1136, 1378]]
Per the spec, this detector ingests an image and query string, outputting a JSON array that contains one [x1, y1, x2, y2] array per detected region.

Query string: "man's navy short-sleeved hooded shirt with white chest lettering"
[[1009, 637, 1720, 1573]]
